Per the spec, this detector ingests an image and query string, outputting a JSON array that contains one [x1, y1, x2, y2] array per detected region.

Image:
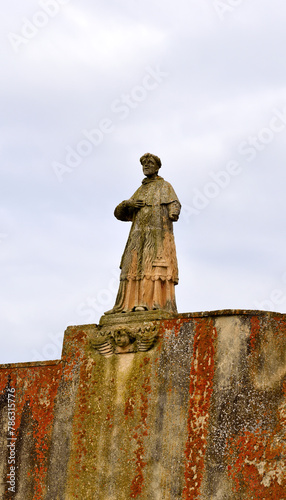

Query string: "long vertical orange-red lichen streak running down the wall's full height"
[[183, 319, 217, 500]]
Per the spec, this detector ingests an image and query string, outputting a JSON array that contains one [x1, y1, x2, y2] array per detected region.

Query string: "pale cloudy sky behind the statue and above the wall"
[[0, 0, 286, 363]]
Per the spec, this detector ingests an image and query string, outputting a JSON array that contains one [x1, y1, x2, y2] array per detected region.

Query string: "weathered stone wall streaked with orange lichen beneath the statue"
[[0, 311, 286, 500]]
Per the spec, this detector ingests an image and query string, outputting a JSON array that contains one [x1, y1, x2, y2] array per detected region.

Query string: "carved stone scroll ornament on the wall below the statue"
[[89, 324, 159, 358]]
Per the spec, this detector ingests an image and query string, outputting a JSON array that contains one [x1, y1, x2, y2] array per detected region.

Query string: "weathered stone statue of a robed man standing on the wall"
[[105, 153, 181, 314]]
